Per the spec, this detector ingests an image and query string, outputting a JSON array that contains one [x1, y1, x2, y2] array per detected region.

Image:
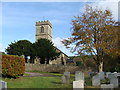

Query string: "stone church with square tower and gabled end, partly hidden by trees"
[[35, 20, 68, 65]]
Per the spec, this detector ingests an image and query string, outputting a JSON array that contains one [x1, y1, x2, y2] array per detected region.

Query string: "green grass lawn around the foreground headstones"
[[3, 72, 100, 89]]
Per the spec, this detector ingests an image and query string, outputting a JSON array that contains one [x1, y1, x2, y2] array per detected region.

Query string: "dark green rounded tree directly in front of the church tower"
[[33, 39, 60, 64]]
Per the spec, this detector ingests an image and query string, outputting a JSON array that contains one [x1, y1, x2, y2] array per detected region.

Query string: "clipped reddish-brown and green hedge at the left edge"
[[2, 55, 25, 77]]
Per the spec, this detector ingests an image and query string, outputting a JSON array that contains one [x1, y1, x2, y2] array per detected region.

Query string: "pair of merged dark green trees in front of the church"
[[6, 39, 60, 64]]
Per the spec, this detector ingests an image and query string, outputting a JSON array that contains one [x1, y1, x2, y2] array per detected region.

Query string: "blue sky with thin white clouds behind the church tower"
[[0, 2, 117, 56]]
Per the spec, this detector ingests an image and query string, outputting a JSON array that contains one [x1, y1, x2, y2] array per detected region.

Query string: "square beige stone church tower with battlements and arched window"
[[36, 20, 52, 41]]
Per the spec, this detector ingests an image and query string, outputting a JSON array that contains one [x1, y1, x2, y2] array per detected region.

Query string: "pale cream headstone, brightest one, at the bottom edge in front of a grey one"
[[73, 80, 84, 90]]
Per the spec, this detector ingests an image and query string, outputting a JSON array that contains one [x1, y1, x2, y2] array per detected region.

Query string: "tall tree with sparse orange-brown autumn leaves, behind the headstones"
[[62, 5, 120, 72]]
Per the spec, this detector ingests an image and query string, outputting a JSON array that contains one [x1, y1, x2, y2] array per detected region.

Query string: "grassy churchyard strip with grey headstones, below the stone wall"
[[0, 71, 120, 90]]
